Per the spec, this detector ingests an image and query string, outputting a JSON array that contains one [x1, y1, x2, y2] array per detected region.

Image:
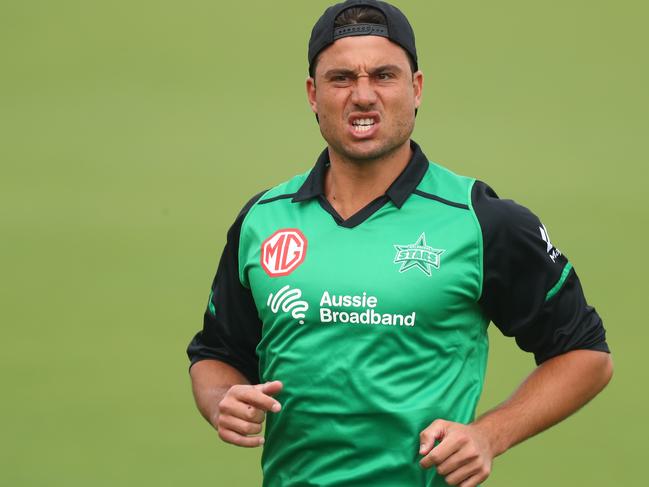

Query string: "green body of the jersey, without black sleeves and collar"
[[239, 163, 488, 487]]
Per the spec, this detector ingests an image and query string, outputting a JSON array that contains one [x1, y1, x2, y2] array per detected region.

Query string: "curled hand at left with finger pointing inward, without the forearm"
[[211, 380, 284, 448]]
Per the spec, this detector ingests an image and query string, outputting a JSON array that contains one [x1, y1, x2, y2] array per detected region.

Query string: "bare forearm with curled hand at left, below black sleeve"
[[190, 360, 282, 447]]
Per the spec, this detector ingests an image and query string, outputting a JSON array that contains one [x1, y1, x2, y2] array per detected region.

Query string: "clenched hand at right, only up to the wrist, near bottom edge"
[[419, 419, 494, 487]]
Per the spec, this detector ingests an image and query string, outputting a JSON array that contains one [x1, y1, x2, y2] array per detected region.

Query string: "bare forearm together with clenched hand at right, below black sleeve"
[[420, 350, 613, 487]]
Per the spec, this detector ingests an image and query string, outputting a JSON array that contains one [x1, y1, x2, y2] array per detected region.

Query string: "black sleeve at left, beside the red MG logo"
[[187, 192, 264, 384]]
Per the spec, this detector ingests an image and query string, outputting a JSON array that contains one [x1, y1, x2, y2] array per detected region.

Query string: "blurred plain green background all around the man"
[[0, 0, 649, 487]]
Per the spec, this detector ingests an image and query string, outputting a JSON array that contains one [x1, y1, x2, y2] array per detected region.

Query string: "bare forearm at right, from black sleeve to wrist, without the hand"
[[473, 350, 613, 456]]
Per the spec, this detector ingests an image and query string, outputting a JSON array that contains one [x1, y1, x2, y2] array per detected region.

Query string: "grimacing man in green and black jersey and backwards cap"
[[188, 0, 612, 487]]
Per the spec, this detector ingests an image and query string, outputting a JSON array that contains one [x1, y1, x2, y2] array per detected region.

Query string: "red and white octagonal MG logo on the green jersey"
[[261, 228, 307, 277]]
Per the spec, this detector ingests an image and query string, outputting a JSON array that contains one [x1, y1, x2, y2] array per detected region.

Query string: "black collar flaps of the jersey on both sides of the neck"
[[292, 140, 428, 208]]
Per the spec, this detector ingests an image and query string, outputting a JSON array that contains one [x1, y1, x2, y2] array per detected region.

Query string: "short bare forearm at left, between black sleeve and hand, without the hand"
[[189, 360, 249, 425]]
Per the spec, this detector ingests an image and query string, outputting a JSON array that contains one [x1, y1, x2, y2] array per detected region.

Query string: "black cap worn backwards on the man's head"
[[309, 0, 419, 76]]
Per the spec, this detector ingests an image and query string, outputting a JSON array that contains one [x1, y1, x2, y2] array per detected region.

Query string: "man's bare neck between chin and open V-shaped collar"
[[324, 140, 412, 219]]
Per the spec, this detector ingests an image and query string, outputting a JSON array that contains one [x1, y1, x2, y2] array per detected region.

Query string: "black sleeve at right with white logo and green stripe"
[[471, 181, 609, 364]]
